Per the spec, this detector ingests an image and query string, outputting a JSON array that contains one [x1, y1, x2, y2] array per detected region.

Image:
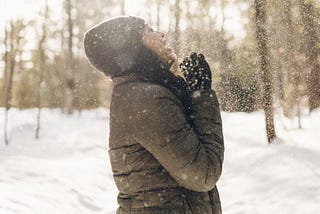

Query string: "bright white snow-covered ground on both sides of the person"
[[0, 109, 320, 214]]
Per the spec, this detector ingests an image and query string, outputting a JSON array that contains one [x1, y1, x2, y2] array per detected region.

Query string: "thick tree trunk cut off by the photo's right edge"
[[300, 0, 320, 112]]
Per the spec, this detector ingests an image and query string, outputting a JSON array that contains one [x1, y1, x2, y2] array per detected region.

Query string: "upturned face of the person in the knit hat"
[[142, 26, 176, 67]]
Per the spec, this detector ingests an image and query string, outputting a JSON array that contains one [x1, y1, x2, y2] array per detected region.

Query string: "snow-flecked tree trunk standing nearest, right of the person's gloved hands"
[[254, 0, 276, 143]]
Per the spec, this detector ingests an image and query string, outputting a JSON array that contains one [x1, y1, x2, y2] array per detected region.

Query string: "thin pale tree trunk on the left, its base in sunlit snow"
[[35, 0, 49, 139]]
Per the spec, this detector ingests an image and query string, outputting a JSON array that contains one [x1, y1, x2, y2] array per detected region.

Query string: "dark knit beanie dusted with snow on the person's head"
[[84, 16, 146, 78]]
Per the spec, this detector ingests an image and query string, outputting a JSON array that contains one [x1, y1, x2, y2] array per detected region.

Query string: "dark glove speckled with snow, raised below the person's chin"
[[179, 52, 212, 93]]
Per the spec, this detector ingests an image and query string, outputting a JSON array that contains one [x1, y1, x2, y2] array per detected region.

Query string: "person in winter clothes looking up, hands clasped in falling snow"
[[84, 17, 224, 214]]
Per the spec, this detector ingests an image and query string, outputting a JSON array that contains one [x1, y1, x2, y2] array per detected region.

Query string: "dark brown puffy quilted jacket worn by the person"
[[109, 73, 224, 214]]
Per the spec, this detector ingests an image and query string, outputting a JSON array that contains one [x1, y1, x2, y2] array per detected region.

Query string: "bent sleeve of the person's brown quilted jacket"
[[131, 86, 224, 192]]
